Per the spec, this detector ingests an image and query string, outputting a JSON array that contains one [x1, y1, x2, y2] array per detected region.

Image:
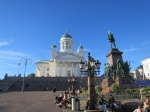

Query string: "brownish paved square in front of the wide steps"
[[0, 91, 75, 112]]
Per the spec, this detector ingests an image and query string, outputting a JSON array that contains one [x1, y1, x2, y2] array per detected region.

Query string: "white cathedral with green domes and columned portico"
[[36, 32, 84, 77]]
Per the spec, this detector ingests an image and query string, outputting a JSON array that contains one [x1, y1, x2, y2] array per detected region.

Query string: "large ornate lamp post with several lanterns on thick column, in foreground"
[[79, 53, 101, 110]]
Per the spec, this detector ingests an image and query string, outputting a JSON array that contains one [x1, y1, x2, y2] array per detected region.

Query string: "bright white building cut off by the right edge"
[[141, 58, 150, 79]]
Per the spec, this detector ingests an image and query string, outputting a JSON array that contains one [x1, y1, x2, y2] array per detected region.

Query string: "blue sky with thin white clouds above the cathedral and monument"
[[0, 0, 150, 79]]
